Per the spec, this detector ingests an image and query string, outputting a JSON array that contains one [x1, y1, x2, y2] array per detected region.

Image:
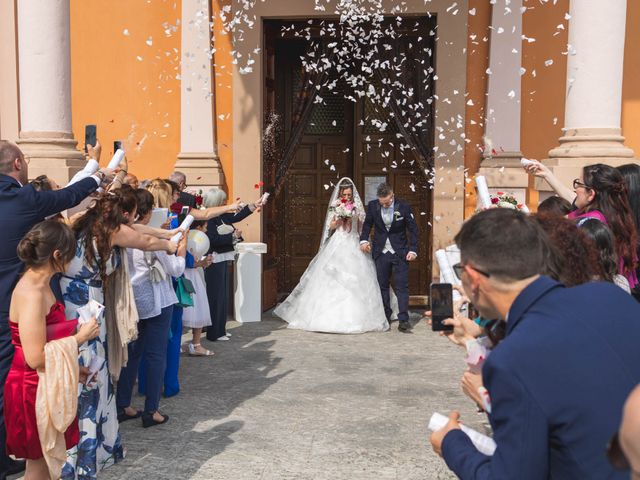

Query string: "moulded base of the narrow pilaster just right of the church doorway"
[[478, 152, 529, 203]]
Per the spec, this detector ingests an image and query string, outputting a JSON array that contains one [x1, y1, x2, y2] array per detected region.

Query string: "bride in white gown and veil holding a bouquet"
[[274, 178, 389, 333]]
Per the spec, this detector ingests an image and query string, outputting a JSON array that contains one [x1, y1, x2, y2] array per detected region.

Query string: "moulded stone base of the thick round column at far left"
[[16, 132, 86, 186]]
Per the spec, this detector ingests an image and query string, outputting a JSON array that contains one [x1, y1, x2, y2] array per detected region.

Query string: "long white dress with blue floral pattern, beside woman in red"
[[60, 241, 124, 480]]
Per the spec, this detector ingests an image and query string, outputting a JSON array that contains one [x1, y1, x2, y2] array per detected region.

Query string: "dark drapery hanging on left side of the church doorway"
[[274, 42, 335, 195]]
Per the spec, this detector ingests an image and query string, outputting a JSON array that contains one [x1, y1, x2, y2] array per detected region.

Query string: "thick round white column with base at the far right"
[[537, 0, 634, 190]]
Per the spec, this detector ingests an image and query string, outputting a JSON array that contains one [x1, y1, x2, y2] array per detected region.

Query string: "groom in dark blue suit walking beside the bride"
[[360, 183, 418, 332]]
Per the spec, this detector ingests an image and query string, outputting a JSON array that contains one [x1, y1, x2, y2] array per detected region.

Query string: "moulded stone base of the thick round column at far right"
[[535, 128, 639, 200]]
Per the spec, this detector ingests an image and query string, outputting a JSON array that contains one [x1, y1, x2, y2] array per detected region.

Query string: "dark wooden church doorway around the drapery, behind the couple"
[[263, 16, 436, 297]]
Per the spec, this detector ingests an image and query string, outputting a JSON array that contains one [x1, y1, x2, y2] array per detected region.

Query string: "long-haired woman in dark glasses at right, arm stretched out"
[[525, 161, 638, 289]]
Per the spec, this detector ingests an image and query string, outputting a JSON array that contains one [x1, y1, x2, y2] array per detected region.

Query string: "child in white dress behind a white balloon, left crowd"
[[182, 220, 214, 357]]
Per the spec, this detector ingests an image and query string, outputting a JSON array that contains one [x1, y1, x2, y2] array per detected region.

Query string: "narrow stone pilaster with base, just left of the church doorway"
[[176, 0, 224, 190]]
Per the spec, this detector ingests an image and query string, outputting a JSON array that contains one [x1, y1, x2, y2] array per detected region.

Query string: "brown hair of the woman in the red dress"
[[17, 220, 76, 272]]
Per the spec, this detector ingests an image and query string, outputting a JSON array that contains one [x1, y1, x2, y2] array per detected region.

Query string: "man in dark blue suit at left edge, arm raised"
[[0, 140, 113, 480]]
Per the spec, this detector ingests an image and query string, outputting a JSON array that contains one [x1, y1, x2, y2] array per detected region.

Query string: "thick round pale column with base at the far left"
[[17, 0, 85, 184]]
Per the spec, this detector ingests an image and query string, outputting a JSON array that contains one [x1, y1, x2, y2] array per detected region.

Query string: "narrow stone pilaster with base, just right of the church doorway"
[[478, 0, 529, 203]]
